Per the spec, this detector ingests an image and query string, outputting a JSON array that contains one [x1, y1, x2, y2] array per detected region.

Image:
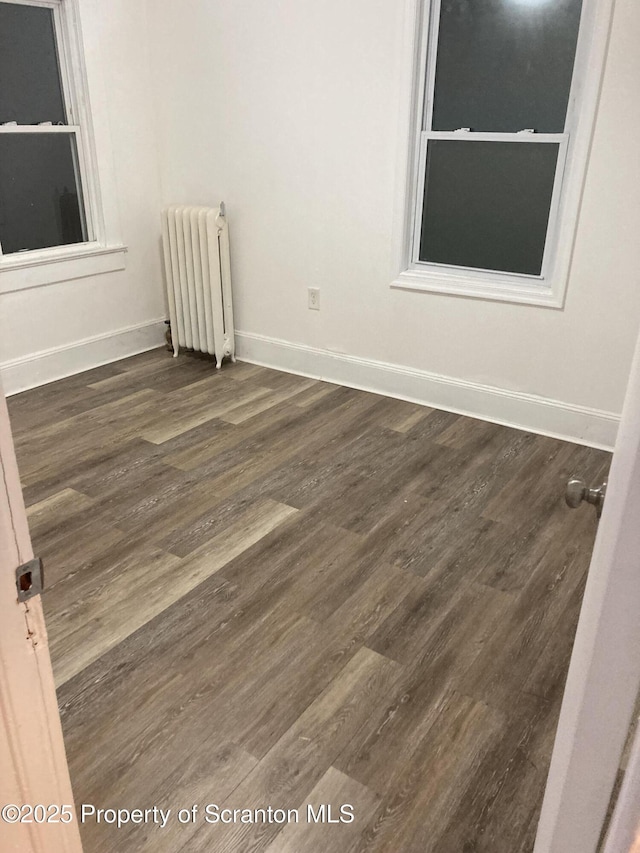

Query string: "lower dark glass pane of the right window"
[[420, 139, 559, 275]]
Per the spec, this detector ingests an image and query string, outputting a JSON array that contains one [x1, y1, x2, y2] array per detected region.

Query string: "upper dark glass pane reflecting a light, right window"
[[432, 0, 582, 133]]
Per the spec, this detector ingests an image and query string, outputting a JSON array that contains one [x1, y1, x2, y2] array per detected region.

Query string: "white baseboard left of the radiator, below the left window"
[[0, 319, 166, 396]]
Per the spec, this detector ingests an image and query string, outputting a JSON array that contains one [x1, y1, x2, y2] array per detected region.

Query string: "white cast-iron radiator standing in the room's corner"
[[162, 202, 235, 367]]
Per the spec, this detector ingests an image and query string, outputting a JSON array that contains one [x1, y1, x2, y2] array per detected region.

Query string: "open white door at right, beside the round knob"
[[534, 328, 640, 853]]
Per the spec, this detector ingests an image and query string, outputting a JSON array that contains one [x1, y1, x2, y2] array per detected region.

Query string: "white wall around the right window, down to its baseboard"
[[149, 0, 640, 444]]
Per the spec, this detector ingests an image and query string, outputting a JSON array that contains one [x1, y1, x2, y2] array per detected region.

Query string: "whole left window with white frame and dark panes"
[[0, 0, 124, 292]]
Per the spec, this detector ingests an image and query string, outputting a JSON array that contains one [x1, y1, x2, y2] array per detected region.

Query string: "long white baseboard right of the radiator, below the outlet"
[[236, 332, 620, 450]]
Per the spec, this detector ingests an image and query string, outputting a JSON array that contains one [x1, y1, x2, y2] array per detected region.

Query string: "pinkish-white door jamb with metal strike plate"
[[0, 387, 82, 853]]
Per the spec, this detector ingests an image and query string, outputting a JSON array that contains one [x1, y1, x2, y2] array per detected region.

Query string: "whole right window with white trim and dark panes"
[[394, 0, 604, 307]]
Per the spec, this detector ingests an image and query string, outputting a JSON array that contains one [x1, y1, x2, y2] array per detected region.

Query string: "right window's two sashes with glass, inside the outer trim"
[[412, 0, 582, 285]]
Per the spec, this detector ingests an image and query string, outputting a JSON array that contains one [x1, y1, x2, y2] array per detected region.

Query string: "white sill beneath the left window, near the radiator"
[[0, 244, 127, 293]]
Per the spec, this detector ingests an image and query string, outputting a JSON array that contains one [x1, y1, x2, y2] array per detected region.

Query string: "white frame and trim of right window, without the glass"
[[391, 0, 613, 308]]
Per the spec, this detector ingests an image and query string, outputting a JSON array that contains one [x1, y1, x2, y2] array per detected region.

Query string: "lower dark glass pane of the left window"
[[0, 133, 87, 255]]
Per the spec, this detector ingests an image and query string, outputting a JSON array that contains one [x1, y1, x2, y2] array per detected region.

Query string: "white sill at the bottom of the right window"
[[391, 269, 562, 308]]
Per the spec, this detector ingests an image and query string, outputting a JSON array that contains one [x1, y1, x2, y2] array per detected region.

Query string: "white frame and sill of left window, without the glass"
[[0, 0, 126, 293]]
